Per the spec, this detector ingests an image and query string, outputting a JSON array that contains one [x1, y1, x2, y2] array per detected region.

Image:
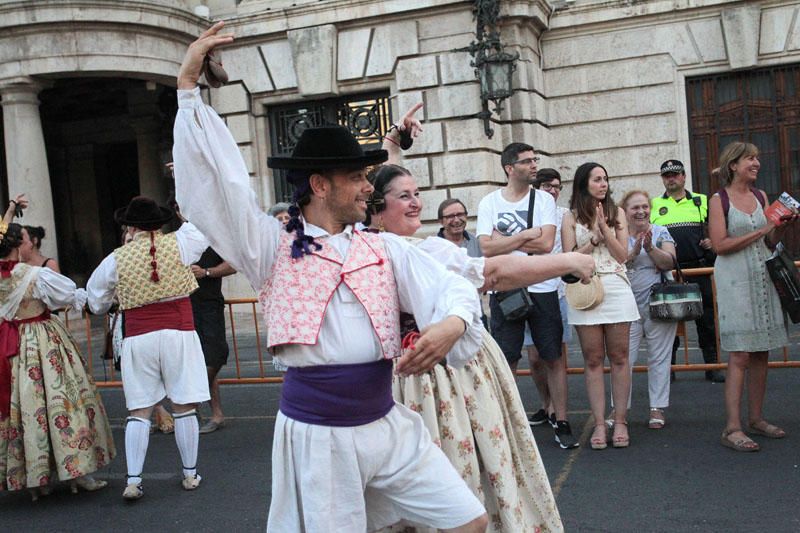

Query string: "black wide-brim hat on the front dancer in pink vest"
[[267, 126, 389, 170]]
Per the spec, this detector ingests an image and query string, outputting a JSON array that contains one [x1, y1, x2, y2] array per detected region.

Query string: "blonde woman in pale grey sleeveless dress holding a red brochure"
[[709, 142, 789, 452]]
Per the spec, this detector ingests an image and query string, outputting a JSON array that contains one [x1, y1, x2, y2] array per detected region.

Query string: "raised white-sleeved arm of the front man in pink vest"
[[173, 23, 283, 289]]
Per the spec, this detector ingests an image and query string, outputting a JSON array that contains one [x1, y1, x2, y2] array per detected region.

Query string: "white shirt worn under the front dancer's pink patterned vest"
[[173, 88, 482, 366]]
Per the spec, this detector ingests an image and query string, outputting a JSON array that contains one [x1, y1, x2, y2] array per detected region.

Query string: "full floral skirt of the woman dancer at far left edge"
[[0, 318, 116, 490]]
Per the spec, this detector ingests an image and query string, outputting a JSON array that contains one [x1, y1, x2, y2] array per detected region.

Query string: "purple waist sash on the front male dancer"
[[280, 359, 394, 427]]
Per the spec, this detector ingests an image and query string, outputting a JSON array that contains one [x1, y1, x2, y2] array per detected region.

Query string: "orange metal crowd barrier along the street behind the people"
[[62, 261, 800, 387]]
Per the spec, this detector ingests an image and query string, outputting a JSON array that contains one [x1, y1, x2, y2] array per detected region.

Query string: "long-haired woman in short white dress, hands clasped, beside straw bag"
[[561, 163, 639, 450]]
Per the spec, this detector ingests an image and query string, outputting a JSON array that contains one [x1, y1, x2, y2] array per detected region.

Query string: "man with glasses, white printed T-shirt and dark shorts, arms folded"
[[476, 143, 578, 449]]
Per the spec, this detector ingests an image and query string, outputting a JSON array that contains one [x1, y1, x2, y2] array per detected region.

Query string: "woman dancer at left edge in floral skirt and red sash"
[[0, 202, 116, 500]]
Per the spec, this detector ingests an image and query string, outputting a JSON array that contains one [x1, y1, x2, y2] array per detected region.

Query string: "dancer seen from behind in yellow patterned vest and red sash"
[[86, 196, 210, 500]]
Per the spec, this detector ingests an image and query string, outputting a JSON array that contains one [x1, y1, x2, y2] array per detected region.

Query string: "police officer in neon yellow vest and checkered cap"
[[650, 159, 725, 383]]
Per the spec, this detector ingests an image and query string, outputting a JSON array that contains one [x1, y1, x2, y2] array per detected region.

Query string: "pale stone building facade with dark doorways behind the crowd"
[[0, 0, 800, 293]]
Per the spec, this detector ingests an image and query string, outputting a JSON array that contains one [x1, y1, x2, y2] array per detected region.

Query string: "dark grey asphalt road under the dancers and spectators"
[[0, 369, 800, 532]]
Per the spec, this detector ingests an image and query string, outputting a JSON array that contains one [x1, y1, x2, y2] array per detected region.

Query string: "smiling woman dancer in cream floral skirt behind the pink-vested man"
[[369, 107, 593, 532]]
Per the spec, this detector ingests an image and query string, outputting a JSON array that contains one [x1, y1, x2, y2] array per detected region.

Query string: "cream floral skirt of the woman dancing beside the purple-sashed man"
[[393, 331, 563, 533]]
